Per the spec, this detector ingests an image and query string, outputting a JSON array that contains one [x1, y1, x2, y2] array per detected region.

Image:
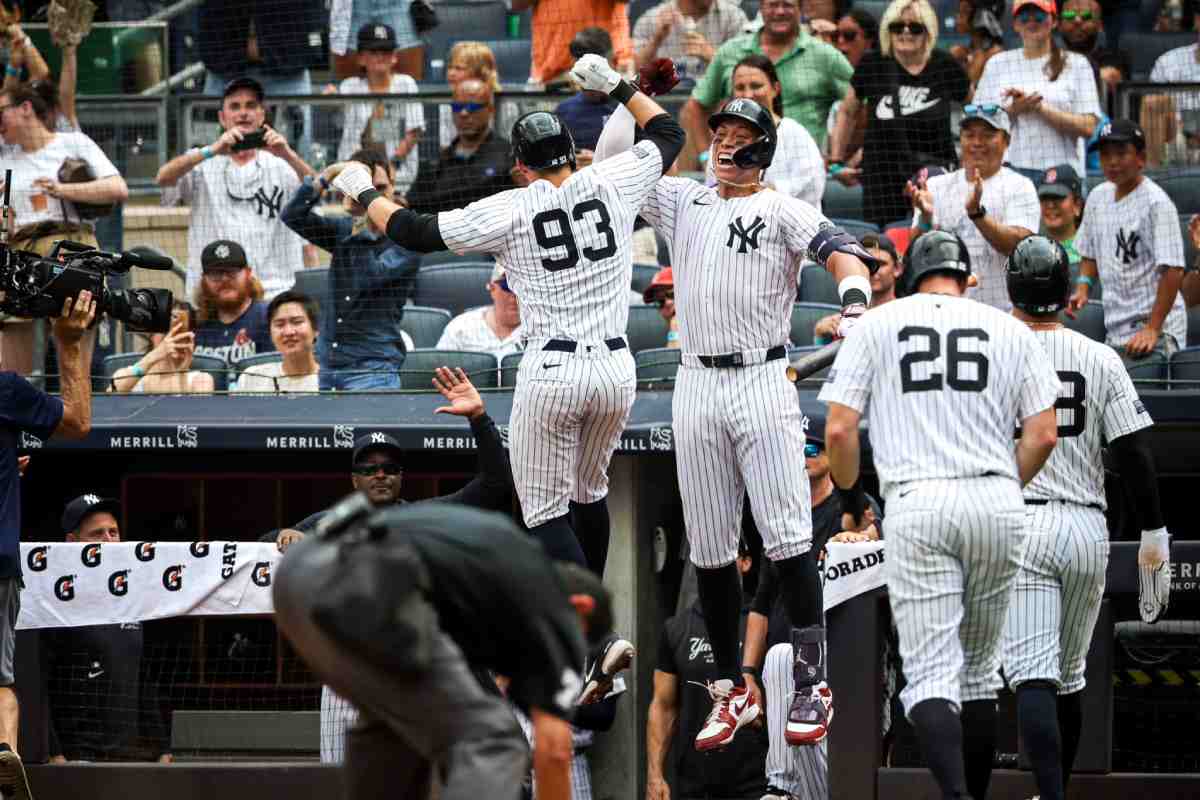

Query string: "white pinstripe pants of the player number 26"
[[883, 476, 1025, 715]]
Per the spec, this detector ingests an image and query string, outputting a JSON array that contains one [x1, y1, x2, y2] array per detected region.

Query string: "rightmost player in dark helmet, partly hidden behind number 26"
[[998, 236, 1171, 800]]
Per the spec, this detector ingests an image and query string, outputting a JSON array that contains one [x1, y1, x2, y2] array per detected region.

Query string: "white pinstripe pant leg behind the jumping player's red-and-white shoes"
[[762, 642, 829, 800]]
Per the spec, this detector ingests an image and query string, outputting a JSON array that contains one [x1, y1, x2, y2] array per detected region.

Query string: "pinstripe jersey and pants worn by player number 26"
[[820, 294, 1058, 714]]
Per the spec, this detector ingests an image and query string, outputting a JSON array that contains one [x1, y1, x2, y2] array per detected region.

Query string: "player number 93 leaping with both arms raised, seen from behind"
[[334, 54, 684, 572]]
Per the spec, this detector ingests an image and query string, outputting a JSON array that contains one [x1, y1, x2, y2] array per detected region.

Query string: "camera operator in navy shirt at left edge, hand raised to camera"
[[0, 291, 96, 798]]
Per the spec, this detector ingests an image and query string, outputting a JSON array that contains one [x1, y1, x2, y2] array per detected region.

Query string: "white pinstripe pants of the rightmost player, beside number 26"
[[1004, 503, 1109, 694]]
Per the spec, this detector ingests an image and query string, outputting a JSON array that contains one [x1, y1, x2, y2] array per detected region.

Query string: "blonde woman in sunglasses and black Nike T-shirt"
[[829, 0, 970, 225]]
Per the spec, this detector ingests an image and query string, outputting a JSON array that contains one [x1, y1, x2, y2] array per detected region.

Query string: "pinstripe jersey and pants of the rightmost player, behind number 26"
[[1004, 327, 1153, 694]]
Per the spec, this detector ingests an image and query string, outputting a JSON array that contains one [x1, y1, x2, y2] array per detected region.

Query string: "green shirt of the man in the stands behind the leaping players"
[[691, 30, 854, 146]]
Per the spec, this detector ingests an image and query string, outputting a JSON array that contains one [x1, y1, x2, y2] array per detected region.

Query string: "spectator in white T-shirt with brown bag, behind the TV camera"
[[0, 80, 130, 374]]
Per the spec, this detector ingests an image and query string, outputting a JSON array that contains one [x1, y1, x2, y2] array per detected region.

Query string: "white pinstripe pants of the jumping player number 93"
[[509, 339, 637, 528]]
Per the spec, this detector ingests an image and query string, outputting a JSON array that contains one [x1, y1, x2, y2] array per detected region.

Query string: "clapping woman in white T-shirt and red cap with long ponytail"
[[974, 0, 1103, 176]]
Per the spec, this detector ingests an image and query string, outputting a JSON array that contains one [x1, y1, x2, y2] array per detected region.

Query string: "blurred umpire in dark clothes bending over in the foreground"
[[274, 494, 612, 800]]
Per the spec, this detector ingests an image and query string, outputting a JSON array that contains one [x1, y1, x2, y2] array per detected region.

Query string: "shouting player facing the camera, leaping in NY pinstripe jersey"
[[596, 97, 877, 750]]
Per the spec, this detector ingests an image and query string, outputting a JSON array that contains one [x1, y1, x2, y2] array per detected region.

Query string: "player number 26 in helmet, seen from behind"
[[818, 230, 1058, 800]]
